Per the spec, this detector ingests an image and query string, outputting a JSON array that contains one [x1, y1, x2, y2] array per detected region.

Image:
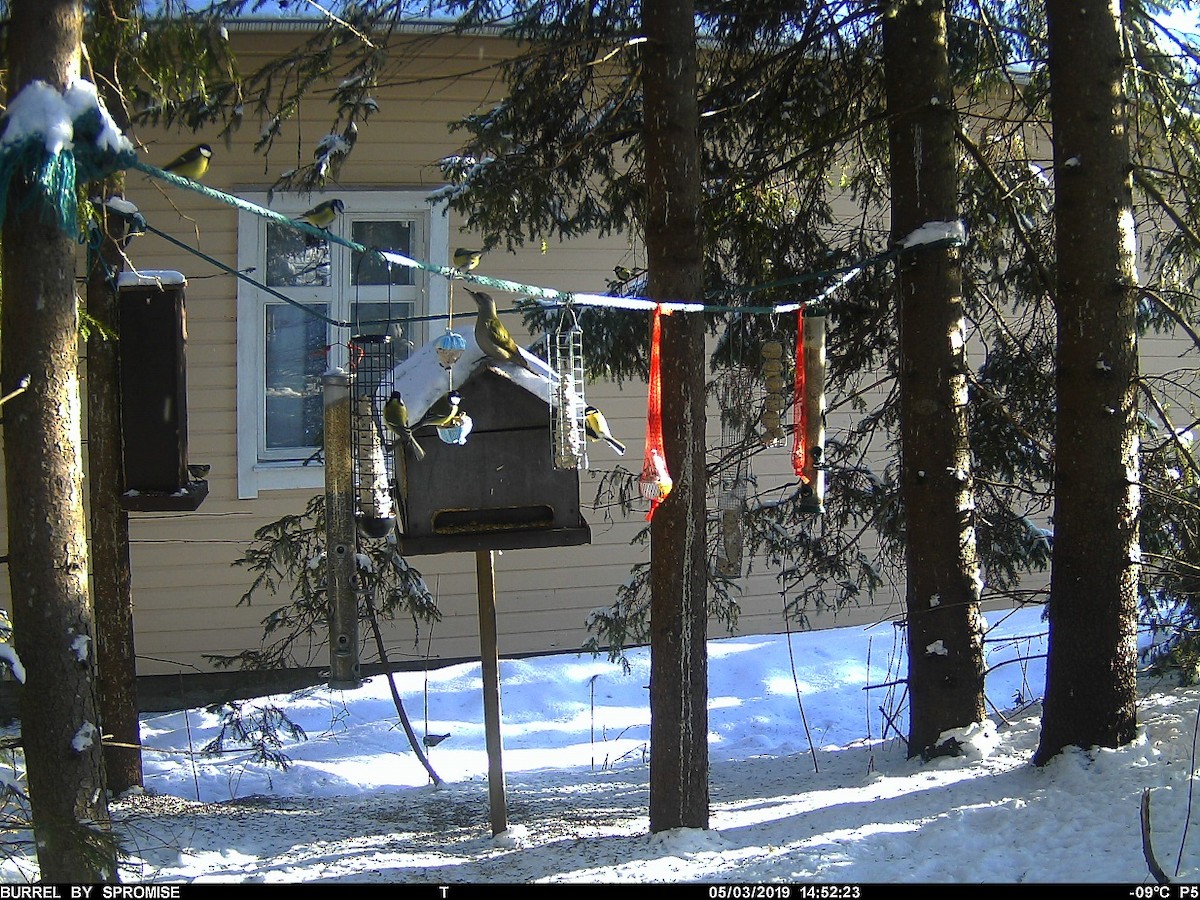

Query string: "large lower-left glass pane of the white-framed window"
[[265, 304, 328, 450]]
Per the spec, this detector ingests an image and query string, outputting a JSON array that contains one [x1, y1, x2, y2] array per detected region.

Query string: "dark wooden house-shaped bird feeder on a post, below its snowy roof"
[[397, 368, 592, 556]]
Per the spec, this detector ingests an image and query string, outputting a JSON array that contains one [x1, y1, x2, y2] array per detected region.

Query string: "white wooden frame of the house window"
[[238, 188, 450, 499]]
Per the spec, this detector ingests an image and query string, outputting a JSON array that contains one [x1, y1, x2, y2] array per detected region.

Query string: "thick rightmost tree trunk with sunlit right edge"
[[1034, 0, 1140, 764]]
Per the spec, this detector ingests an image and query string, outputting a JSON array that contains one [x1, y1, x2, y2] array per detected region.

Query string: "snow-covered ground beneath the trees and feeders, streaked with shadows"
[[0, 610, 1200, 884]]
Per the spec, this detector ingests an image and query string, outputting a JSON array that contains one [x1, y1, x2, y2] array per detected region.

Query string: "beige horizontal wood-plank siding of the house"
[[9, 24, 1177, 676]]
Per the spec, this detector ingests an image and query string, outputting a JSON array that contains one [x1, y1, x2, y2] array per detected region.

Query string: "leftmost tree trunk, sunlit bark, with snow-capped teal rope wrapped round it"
[[0, 0, 115, 882]]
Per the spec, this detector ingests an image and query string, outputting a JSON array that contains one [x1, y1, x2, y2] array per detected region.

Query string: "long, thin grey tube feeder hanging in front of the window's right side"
[[323, 372, 360, 690]]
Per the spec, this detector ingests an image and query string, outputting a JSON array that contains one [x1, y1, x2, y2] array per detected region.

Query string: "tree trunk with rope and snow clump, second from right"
[[883, 0, 985, 756]]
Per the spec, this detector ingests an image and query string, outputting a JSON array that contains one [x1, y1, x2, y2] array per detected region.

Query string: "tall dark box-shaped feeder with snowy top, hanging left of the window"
[[118, 272, 209, 511]]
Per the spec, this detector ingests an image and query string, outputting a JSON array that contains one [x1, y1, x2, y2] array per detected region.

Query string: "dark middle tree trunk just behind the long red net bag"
[[642, 0, 708, 832]]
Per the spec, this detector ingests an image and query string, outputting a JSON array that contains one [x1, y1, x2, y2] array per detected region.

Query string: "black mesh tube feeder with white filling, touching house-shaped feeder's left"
[[350, 335, 396, 538]]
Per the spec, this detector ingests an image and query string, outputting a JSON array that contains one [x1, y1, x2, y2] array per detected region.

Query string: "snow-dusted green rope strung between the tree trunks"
[[131, 161, 960, 328]]
